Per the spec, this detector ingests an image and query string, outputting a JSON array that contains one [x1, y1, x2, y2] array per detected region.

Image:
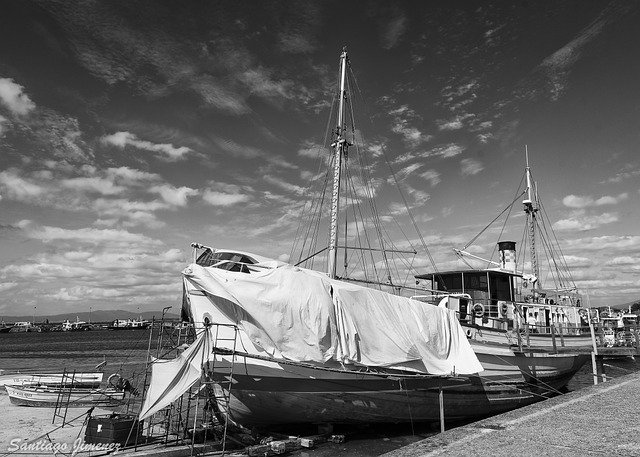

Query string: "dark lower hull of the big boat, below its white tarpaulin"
[[208, 348, 588, 426]]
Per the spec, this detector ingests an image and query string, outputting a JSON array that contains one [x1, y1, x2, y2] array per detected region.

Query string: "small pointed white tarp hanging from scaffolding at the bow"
[[140, 328, 213, 420]]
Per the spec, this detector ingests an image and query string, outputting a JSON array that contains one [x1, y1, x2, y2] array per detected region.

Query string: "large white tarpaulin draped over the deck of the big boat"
[[183, 262, 482, 375]]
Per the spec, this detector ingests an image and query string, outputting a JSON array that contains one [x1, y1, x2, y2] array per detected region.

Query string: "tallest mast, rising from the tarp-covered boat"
[[328, 48, 349, 278]]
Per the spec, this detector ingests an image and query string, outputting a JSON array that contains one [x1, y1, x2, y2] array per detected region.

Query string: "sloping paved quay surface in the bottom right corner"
[[384, 373, 640, 457]]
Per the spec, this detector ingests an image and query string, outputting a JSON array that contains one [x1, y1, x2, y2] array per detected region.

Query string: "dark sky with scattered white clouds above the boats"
[[0, 0, 640, 315]]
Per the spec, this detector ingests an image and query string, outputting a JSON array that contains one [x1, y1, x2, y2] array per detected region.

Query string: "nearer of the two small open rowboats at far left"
[[7, 386, 124, 408]]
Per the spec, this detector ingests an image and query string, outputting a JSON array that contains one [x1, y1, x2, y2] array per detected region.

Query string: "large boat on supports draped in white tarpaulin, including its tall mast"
[[140, 51, 584, 425]]
